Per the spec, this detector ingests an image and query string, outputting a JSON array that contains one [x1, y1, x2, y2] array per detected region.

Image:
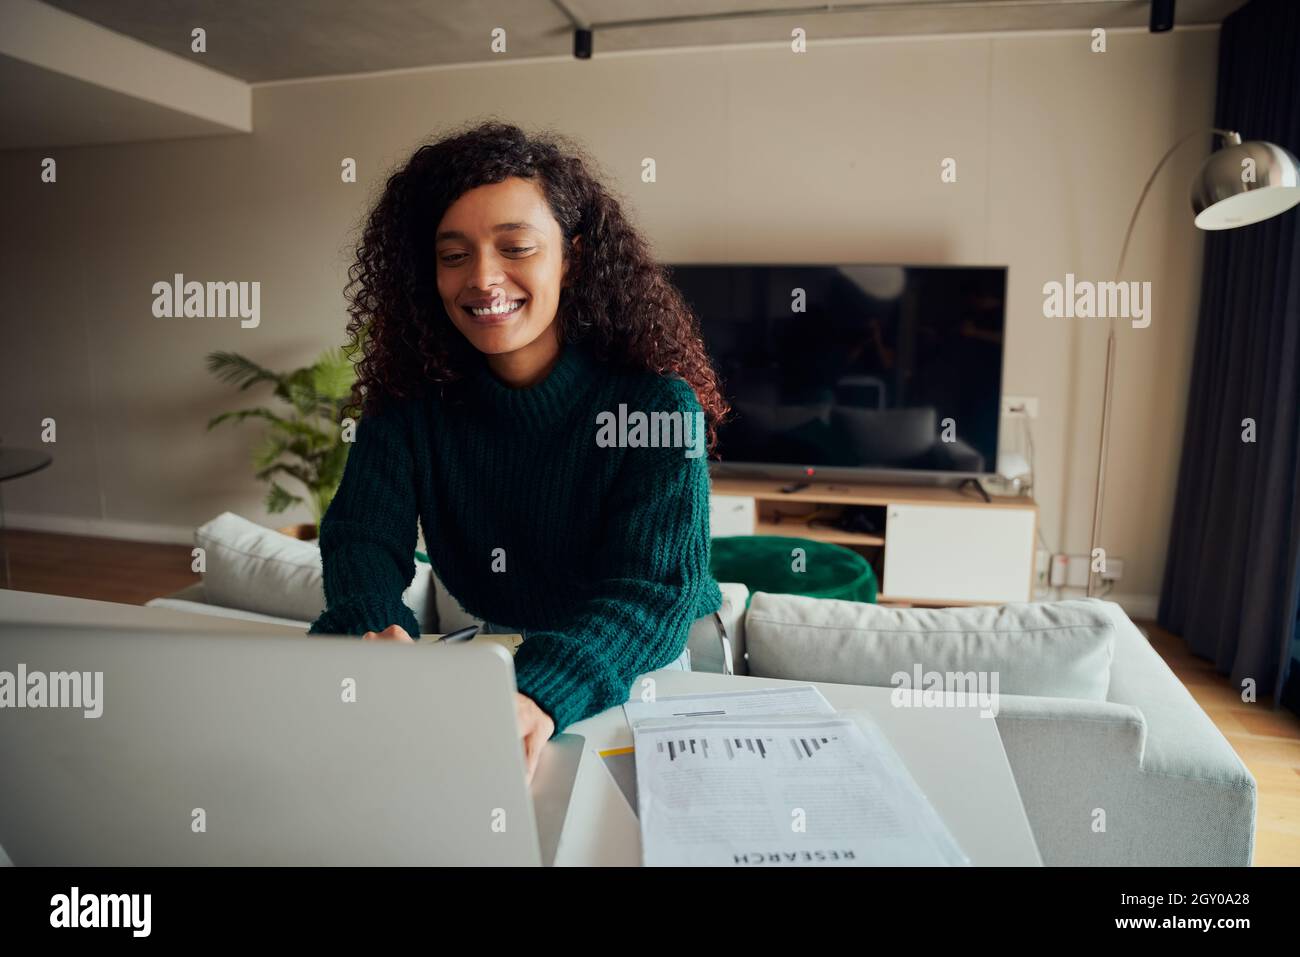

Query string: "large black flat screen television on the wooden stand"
[[668, 264, 1006, 482]]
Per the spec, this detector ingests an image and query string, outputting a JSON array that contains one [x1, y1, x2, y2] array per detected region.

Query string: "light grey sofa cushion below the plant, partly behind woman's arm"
[[194, 512, 437, 632]]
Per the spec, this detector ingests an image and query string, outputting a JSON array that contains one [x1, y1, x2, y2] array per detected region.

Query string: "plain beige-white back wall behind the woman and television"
[[0, 29, 1218, 613]]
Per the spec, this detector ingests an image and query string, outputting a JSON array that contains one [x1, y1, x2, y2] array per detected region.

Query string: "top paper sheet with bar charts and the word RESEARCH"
[[632, 714, 970, 867]]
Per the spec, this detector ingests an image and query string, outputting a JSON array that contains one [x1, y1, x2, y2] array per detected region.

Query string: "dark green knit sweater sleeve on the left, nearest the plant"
[[308, 408, 420, 638]]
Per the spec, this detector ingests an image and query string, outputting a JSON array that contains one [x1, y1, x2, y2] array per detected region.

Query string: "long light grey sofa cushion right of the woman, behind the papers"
[[745, 592, 1115, 701]]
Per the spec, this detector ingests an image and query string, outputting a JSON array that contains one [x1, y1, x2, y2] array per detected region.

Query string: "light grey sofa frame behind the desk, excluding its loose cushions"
[[148, 522, 1256, 866]]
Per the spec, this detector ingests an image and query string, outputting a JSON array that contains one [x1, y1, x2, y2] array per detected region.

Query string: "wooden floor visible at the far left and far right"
[[0, 531, 1300, 867]]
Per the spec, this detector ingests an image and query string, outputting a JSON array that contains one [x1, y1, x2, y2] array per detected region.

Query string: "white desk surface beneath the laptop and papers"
[[0, 589, 1043, 866]]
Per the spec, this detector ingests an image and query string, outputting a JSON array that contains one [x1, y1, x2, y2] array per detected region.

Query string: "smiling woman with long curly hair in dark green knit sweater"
[[311, 122, 729, 776]]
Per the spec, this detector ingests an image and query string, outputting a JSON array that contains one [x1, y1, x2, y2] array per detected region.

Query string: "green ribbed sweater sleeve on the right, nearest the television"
[[515, 386, 722, 735]]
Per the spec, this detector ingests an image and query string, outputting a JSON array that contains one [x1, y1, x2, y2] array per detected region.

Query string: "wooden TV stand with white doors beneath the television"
[[711, 477, 1037, 606]]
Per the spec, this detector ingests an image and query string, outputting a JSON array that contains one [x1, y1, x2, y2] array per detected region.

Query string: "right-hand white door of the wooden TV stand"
[[880, 505, 1034, 602]]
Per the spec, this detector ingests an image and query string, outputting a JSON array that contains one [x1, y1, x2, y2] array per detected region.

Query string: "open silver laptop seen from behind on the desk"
[[0, 623, 584, 866]]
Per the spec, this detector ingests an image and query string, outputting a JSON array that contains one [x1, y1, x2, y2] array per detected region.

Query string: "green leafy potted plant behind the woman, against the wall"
[[207, 347, 356, 540]]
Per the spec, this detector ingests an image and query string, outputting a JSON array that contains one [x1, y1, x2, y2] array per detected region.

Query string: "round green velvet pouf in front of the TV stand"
[[710, 534, 876, 607]]
